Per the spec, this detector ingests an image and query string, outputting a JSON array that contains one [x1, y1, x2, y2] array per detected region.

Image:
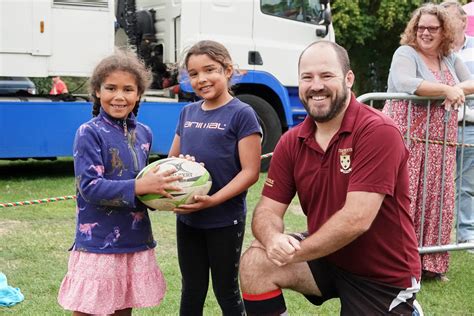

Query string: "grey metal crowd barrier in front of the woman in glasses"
[[357, 92, 474, 254]]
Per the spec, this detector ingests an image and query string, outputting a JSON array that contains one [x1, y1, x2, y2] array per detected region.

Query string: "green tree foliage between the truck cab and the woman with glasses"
[[331, 0, 467, 95]]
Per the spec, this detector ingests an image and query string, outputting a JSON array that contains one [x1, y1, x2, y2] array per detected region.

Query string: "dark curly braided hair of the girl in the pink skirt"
[[89, 50, 153, 116]]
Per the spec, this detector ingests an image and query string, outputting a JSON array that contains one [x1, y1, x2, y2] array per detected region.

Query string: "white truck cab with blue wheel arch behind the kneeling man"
[[117, 0, 334, 169]]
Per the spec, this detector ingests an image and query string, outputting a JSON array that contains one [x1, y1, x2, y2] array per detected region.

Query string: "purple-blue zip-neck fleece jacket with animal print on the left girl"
[[72, 109, 156, 253]]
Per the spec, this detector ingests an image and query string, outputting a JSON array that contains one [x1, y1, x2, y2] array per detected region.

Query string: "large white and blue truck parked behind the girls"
[[0, 0, 334, 168]]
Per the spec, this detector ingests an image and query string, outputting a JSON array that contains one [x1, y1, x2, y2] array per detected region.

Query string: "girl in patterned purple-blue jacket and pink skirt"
[[58, 51, 179, 315]]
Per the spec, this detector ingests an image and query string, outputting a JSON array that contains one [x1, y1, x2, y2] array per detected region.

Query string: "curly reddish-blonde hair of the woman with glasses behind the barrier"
[[400, 3, 455, 56]]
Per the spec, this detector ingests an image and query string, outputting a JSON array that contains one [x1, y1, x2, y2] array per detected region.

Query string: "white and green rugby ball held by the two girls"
[[137, 158, 212, 211]]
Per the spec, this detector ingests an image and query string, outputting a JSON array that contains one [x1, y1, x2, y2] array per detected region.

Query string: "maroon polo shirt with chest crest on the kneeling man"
[[263, 95, 421, 288]]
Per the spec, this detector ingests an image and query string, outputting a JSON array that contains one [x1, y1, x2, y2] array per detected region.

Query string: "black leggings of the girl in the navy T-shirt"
[[176, 220, 245, 316]]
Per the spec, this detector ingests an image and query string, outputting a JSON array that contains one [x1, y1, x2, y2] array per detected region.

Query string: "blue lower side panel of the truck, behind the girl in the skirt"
[[0, 100, 182, 159]]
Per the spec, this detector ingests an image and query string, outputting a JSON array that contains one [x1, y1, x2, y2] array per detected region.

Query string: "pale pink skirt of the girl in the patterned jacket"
[[58, 249, 166, 314]]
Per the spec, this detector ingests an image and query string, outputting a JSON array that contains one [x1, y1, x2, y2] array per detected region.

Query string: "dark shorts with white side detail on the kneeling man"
[[305, 259, 419, 315]]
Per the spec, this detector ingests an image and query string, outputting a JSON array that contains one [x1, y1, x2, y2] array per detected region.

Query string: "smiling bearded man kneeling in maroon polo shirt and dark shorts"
[[240, 41, 420, 315]]
